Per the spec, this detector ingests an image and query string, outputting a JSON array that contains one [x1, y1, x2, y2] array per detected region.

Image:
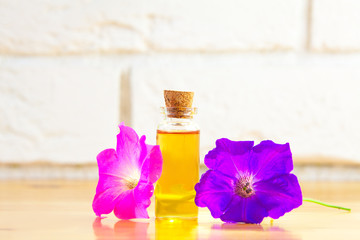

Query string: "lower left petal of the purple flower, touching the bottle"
[[195, 170, 234, 218]]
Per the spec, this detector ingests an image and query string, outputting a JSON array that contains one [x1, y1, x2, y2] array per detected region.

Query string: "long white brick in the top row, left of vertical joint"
[[0, 0, 305, 55]]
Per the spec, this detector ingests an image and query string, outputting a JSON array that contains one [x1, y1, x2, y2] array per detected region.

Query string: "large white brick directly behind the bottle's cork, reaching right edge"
[[132, 54, 360, 164]]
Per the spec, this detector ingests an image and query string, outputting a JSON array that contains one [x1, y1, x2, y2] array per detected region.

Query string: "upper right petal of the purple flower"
[[250, 140, 293, 180]]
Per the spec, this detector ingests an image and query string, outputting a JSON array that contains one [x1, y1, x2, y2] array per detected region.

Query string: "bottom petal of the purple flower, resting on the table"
[[220, 195, 268, 223]]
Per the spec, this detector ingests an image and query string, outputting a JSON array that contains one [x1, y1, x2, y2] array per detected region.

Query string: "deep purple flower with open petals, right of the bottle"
[[195, 138, 302, 223]]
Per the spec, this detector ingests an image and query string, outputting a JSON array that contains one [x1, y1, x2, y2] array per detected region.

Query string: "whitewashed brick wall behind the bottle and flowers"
[[0, 0, 360, 181]]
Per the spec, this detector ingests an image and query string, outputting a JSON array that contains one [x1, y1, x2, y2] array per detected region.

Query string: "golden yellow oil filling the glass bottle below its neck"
[[155, 130, 200, 218]]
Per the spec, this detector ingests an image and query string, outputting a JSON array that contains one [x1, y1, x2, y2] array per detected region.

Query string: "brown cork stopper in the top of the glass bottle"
[[164, 90, 194, 118]]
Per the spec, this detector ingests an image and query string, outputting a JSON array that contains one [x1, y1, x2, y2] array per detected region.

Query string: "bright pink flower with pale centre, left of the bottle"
[[92, 123, 162, 219]]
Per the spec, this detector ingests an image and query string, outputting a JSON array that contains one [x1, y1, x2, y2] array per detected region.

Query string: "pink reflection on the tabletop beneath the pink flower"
[[93, 217, 150, 240]]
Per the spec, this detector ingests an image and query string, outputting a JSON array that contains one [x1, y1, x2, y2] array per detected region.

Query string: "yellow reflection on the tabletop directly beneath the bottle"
[[155, 218, 198, 240]]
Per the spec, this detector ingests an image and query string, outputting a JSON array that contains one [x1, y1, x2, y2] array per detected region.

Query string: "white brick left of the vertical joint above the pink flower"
[[0, 57, 121, 163]]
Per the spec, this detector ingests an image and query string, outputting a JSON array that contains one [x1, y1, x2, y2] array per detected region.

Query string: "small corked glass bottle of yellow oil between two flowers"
[[155, 90, 200, 218]]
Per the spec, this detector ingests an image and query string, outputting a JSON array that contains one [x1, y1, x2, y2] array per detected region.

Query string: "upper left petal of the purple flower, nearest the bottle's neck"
[[204, 138, 254, 178]]
